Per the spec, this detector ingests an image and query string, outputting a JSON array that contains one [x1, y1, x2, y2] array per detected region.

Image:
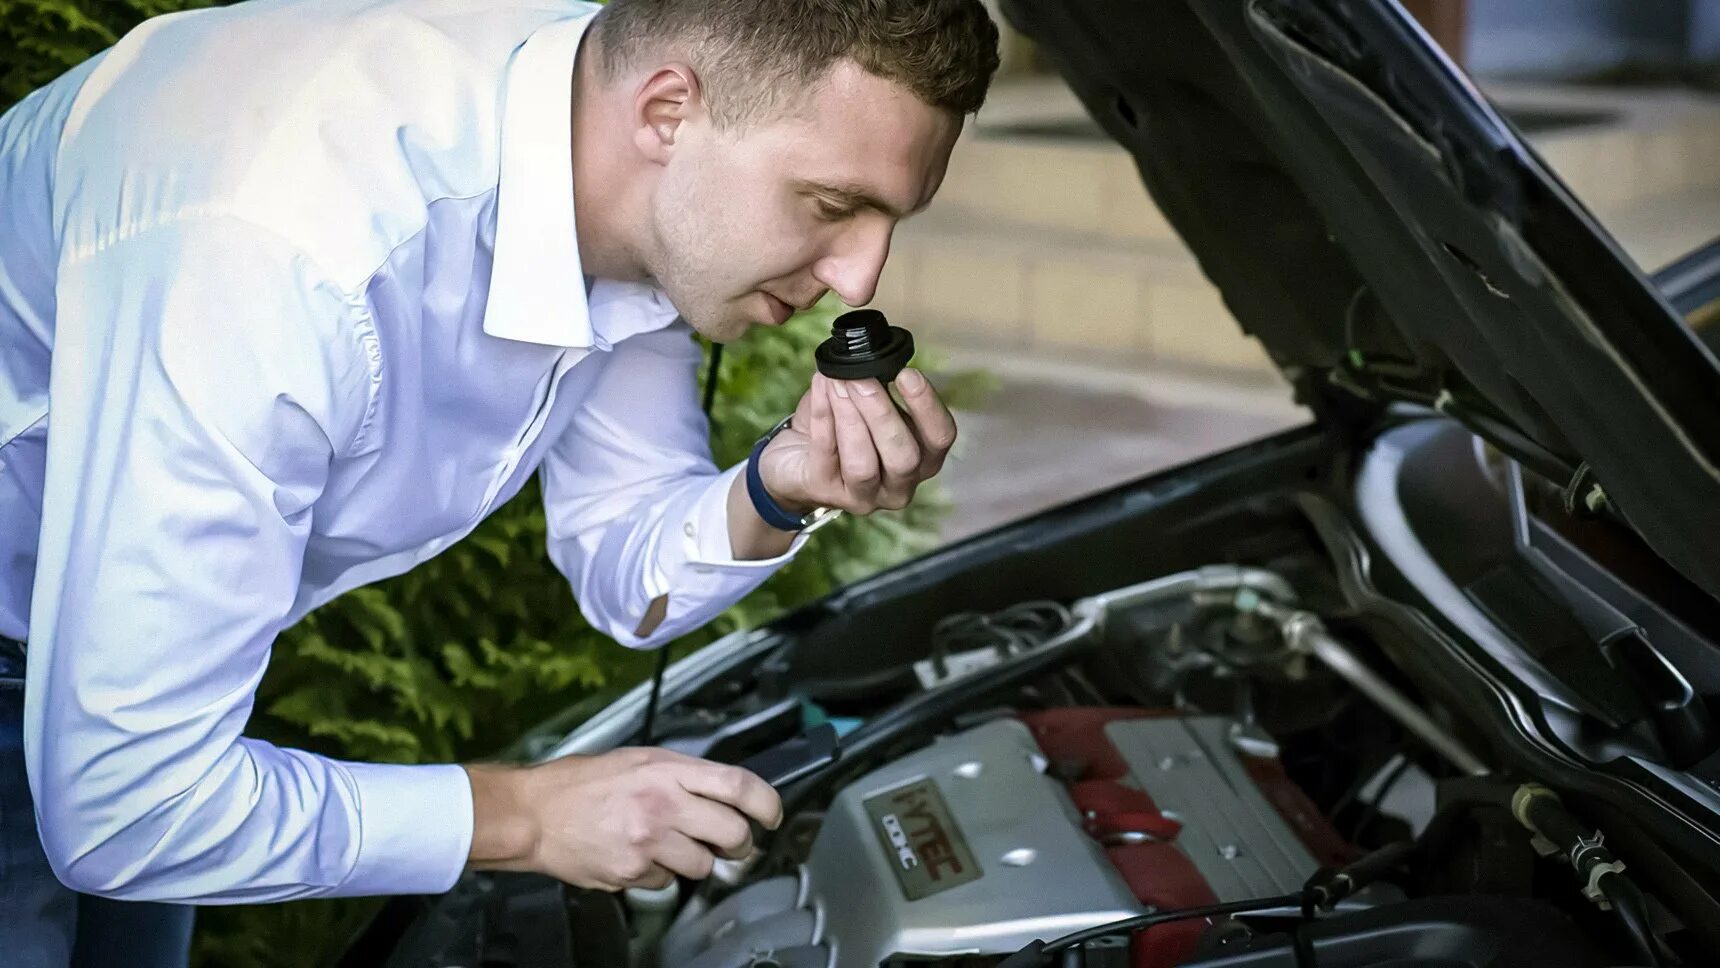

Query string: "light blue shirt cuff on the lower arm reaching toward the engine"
[[341, 763, 471, 898]]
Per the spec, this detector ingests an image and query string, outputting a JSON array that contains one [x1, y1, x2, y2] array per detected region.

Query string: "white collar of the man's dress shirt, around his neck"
[[483, 3, 676, 349]]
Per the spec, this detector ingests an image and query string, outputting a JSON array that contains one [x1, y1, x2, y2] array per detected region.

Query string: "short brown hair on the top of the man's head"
[[593, 0, 998, 126]]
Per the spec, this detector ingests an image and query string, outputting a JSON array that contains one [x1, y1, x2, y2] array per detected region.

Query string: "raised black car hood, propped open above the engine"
[[1003, 0, 1720, 597]]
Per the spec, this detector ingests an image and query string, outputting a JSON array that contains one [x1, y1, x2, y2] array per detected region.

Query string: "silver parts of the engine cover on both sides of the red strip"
[[662, 717, 1316, 968]]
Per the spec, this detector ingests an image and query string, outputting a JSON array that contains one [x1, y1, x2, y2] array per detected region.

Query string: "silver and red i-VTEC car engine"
[[660, 708, 1345, 968]]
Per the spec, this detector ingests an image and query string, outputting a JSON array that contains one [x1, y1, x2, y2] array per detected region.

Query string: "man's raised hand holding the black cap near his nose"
[[759, 368, 956, 514]]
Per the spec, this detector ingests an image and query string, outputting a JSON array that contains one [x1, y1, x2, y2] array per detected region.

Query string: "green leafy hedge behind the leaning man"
[[0, 0, 982, 968]]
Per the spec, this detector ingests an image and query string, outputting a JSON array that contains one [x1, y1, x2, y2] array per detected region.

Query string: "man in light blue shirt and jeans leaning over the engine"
[[0, 0, 996, 966]]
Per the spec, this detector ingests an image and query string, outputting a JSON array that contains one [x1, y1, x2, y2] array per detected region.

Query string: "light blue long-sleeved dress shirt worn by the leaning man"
[[0, 0, 805, 903]]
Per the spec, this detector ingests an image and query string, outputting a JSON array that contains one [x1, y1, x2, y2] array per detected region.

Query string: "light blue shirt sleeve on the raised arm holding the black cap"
[[540, 322, 807, 648]]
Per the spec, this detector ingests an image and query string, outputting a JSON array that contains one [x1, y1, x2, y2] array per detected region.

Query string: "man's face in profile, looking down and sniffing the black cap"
[[647, 60, 961, 342]]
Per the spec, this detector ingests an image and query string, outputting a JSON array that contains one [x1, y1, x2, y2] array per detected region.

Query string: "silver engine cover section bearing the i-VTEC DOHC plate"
[[807, 719, 1142, 968]]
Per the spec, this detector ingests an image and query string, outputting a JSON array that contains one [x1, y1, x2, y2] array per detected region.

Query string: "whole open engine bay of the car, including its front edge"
[[369, 424, 1720, 968]]
